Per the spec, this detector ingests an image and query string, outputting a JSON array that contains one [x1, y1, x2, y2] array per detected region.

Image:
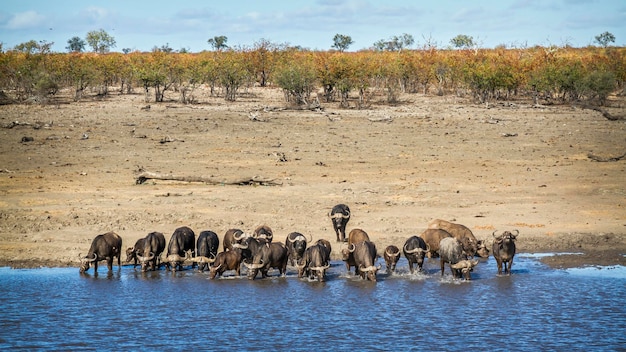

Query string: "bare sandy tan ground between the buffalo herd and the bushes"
[[0, 88, 626, 267]]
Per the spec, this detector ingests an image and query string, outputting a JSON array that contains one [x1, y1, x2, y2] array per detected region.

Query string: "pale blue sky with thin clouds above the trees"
[[0, 0, 626, 52]]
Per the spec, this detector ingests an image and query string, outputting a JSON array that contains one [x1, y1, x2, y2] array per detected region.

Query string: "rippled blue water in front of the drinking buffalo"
[[0, 254, 626, 351]]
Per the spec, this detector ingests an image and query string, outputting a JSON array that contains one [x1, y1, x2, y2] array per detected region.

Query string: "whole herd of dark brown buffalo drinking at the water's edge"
[[80, 204, 519, 282]]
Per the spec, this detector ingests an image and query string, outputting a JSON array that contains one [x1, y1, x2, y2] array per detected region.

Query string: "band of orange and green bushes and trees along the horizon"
[[0, 33, 626, 108]]
